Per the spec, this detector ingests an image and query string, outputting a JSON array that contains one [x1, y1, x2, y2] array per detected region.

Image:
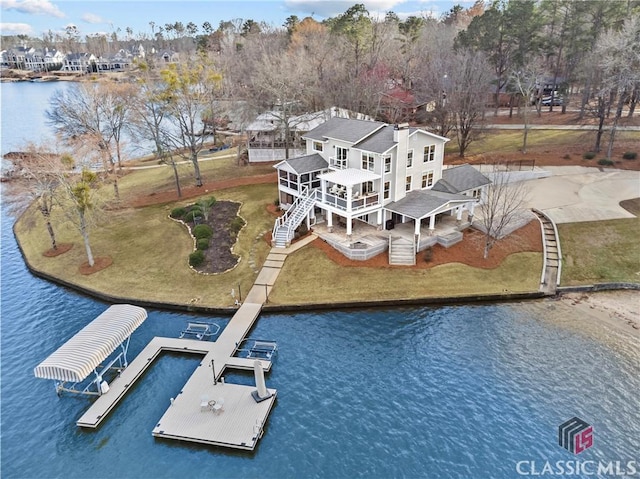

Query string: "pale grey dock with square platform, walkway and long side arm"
[[77, 303, 277, 450]]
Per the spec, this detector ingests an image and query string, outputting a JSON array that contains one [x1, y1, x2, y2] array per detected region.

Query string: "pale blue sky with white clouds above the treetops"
[[0, 0, 473, 38]]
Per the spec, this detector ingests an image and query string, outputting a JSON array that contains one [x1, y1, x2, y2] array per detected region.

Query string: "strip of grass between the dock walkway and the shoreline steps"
[[269, 246, 542, 305]]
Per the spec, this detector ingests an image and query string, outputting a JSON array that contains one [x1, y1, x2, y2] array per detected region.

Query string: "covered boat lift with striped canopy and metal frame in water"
[[34, 304, 147, 396]]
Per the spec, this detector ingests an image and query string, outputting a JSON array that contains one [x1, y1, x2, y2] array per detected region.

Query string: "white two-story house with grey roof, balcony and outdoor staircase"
[[273, 118, 489, 264]]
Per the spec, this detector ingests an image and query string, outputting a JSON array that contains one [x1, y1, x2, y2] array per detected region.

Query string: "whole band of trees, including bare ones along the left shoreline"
[[5, 0, 640, 263]]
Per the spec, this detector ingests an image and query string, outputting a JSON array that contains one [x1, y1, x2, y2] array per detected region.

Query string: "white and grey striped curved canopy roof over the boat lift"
[[34, 304, 147, 383]]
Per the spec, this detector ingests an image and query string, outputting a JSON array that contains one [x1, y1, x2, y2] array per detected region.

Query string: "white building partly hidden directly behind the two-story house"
[[245, 107, 370, 163]]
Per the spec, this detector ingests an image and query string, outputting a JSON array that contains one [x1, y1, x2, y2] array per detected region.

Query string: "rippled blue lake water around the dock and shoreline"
[[0, 83, 640, 478]]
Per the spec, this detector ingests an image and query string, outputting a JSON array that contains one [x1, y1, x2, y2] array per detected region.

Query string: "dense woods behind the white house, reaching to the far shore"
[[4, 0, 640, 160]]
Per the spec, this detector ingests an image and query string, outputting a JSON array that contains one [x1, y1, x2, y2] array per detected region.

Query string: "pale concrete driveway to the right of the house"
[[528, 166, 640, 223]]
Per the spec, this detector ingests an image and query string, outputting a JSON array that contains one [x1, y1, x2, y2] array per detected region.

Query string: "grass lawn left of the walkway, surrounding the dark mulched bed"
[[16, 185, 276, 308]]
